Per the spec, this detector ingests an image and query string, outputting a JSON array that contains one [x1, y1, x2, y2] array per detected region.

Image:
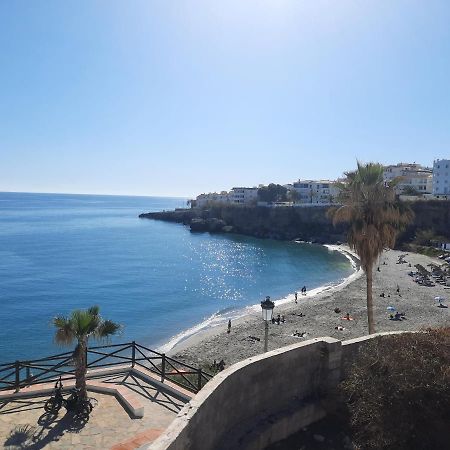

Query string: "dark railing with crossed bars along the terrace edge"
[[0, 341, 212, 393]]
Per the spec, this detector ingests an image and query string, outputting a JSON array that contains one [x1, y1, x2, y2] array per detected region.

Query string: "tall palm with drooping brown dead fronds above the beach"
[[332, 162, 413, 334]]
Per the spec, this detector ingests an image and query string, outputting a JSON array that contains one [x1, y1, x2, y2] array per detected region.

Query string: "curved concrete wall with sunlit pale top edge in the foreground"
[[147, 333, 408, 450]]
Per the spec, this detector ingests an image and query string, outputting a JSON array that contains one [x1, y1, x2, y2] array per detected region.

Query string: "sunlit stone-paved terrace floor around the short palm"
[[0, 374, 184, 450]]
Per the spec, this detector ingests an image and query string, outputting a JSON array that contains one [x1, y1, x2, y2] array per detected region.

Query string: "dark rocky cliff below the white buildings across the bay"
[[139, 201, 450, 245]]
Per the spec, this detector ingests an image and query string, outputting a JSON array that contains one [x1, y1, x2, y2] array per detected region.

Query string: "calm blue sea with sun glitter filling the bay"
[[0, 193, 353, 362]]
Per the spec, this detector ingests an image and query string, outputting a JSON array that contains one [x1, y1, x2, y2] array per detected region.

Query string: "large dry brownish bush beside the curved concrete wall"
[[341, 327, 450, 450]]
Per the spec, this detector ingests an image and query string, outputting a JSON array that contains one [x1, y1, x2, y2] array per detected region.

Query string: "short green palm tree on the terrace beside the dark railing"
[[52, 306, 122, 399]]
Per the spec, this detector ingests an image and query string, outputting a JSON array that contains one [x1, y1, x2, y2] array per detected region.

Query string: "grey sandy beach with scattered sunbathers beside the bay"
[[169, 246, 450, 366]]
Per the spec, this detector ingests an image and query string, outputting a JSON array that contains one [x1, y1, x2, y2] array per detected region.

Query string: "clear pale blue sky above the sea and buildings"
[[0, 0, 450, 196]]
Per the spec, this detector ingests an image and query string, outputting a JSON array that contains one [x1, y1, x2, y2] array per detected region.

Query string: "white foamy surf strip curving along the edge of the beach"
[[162, 244, 362, 356]]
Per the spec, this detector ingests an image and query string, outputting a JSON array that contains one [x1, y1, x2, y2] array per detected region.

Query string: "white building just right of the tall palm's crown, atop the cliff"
[[383, 163, 433, 195]]
